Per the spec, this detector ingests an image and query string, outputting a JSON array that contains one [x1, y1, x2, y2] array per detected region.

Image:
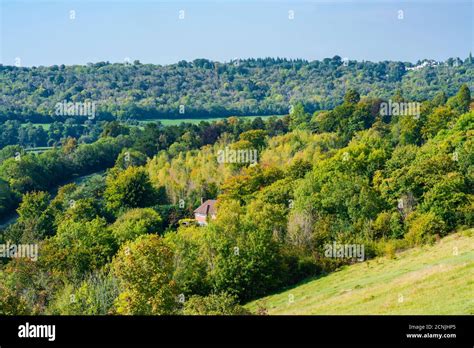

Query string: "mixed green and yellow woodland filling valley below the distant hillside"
[[0, 77, 474, 315]]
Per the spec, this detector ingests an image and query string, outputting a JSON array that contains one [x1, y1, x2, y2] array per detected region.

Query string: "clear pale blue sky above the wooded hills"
[[0, 0, 474, 66]]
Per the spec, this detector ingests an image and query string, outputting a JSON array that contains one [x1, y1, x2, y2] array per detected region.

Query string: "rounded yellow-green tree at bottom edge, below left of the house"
[[112, 235, 178, 315]]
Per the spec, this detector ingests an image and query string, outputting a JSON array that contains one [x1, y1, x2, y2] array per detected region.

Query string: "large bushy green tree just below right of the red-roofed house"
[[205, 201, 285, 301]]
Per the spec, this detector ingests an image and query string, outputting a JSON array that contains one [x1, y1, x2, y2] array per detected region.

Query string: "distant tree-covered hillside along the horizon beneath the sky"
[[0, 56, 474, 122]]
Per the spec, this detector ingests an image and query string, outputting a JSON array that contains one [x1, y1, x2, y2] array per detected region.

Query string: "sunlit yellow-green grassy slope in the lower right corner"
[[246, 229, 474, 315]]
